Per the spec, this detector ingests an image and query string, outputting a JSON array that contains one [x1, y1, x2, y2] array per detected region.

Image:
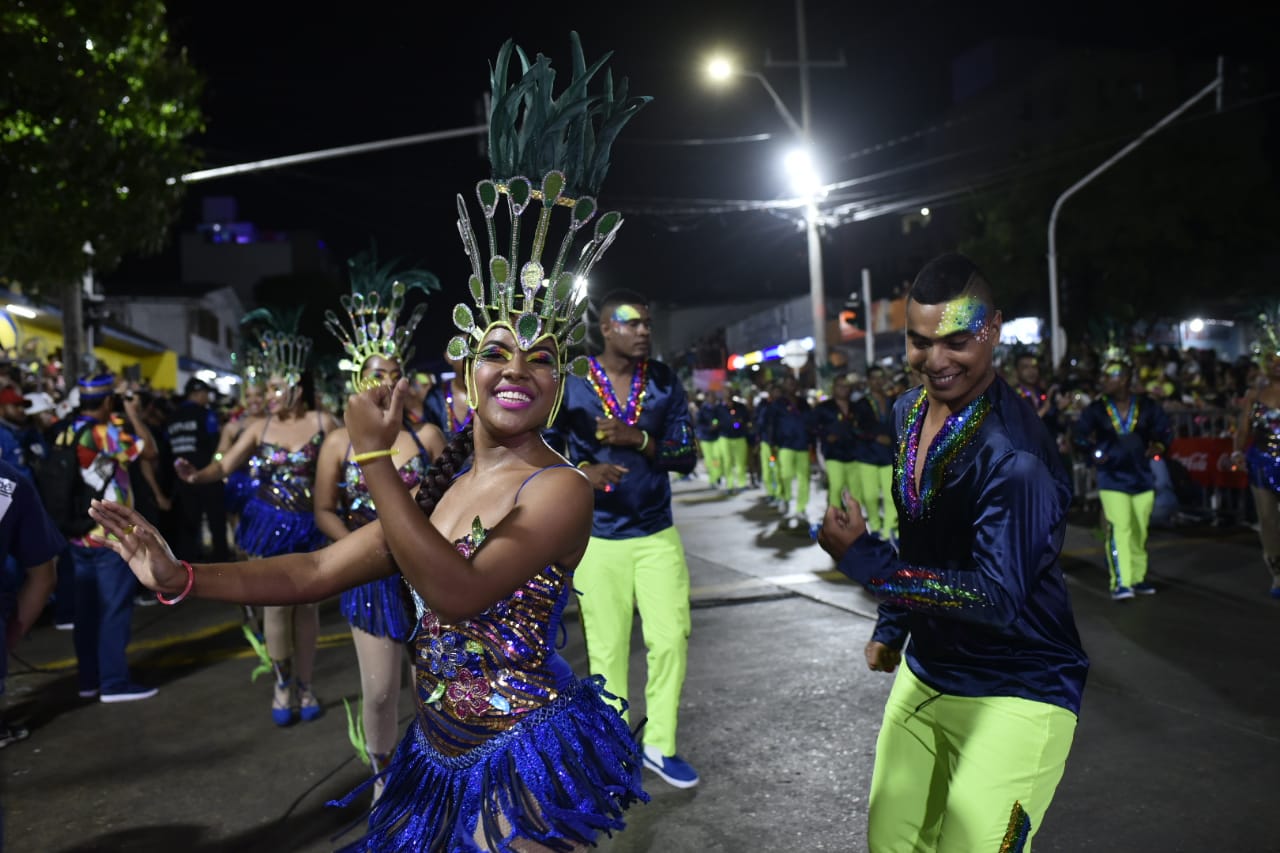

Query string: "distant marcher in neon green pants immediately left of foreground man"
[[850, 366, 897, 542]]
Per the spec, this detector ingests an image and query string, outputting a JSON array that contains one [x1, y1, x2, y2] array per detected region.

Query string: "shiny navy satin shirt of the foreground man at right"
[[838, 378, 1089, 713]]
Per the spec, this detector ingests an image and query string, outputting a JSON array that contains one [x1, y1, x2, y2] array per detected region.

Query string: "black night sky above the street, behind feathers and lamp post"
[[122, 0, 1274, 350]]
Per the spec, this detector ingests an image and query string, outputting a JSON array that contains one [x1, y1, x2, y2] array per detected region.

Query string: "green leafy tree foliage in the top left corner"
[[0, 0, 202, 291]]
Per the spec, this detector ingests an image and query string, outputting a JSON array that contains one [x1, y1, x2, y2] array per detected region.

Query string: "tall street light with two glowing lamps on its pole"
[[707, 55, 827, 375]]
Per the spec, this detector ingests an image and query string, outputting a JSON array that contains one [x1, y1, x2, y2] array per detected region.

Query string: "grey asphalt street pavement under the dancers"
[[0, 479, 1280, 853]]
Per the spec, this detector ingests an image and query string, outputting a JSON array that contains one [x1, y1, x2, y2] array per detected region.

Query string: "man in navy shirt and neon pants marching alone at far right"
[[1075, 348, 1172, 601]]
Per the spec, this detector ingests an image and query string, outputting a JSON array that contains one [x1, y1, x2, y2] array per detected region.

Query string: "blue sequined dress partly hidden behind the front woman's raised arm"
[[338, 453, 429, 643]]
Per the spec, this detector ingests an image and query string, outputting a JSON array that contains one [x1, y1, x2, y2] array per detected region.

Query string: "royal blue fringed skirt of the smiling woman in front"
[[330, 678, 649, 853]]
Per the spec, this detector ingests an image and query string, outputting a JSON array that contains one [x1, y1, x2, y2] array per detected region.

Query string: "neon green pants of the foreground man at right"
[[867, 662, 1075, 853]]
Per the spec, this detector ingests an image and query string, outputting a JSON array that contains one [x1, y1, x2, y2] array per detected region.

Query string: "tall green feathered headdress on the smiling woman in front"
[[448, 33, 650, 418]]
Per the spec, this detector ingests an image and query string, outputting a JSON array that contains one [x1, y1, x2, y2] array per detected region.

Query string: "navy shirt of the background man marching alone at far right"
[[1075, 394, 1172, 494]]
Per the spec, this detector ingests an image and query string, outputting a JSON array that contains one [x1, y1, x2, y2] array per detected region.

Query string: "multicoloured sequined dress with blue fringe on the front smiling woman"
[[344, 469, 649, 853]]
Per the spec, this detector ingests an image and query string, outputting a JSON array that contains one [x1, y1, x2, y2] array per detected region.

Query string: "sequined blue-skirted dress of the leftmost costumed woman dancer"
[[236, 417, 328, 557]]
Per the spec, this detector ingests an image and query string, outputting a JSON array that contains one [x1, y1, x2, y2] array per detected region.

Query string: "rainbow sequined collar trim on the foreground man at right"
[[893, 389, 991, 519]]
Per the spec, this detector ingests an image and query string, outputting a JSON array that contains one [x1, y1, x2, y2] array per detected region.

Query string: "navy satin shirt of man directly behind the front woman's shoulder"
[[556, 359, 698, 539]]
